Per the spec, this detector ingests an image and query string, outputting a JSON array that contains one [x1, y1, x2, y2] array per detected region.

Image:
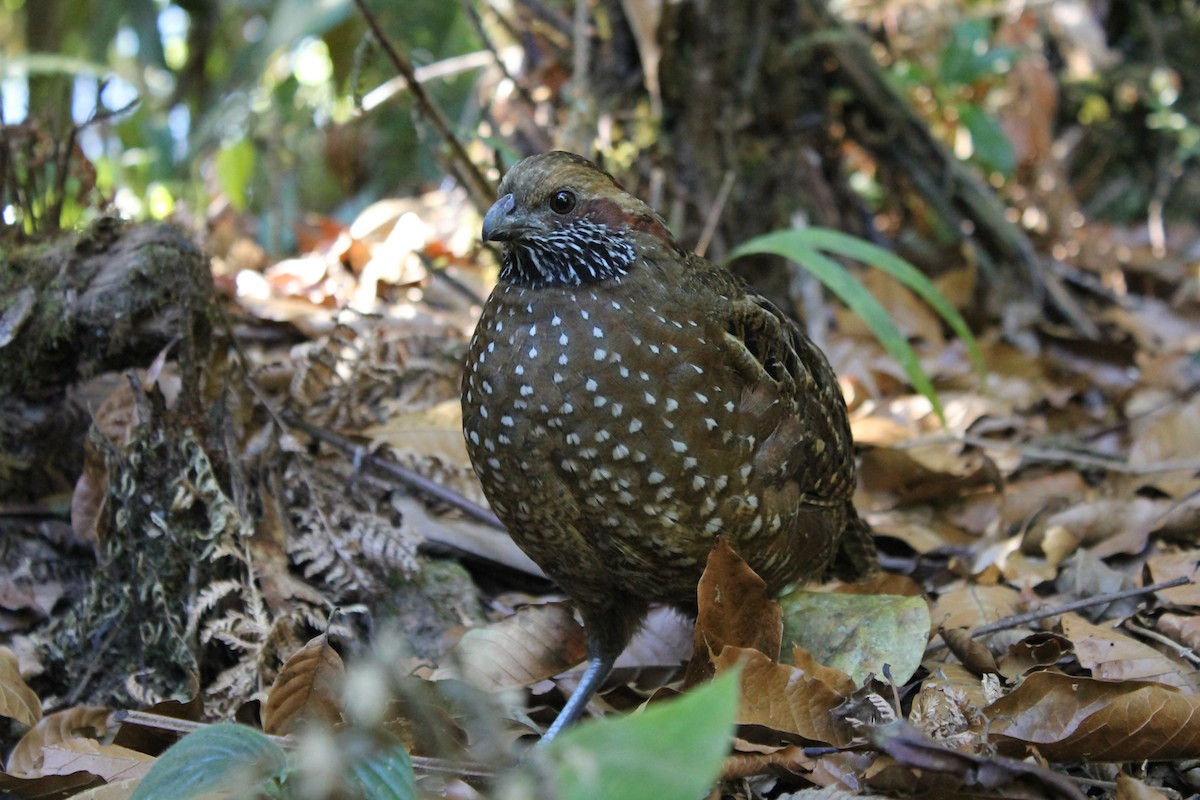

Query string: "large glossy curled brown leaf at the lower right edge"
[[984, 672, 1200, 762]]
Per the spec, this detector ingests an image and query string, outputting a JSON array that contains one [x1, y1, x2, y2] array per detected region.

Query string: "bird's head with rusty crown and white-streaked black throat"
[[484, 151, 677, 288]]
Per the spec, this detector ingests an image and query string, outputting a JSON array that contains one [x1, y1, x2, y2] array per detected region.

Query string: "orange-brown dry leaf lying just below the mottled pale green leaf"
[[713, 648, 854, 747]]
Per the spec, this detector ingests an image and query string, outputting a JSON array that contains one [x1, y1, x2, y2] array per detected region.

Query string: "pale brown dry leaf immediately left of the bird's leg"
[[432, 603, 587, 692]]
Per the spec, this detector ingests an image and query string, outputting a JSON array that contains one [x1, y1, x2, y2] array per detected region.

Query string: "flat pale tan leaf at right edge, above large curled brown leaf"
[[1062, 614, 1200, 693]]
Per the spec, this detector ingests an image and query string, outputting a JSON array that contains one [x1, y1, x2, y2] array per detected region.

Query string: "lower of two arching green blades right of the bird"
[[730, 228, 946, 425]]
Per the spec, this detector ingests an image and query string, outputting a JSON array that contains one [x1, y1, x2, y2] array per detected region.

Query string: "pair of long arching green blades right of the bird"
[[730, 228, 986, 425]]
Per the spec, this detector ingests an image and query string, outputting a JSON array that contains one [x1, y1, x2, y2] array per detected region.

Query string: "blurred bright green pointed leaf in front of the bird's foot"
[[528, 670, 739, 800]]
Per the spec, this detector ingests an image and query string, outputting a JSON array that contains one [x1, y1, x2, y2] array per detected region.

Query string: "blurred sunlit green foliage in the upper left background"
[[0, 0, 480, 251]]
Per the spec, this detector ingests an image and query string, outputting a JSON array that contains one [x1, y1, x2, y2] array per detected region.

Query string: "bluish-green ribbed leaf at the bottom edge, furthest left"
[[130, 723, 288, 800]]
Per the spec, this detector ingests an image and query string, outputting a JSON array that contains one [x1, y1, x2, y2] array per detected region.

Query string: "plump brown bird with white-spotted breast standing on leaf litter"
[[462, 152, 875, 740]]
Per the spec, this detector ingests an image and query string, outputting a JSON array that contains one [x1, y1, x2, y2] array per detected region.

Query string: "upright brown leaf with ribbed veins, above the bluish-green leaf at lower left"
[[263, 633, 346, 736]]
